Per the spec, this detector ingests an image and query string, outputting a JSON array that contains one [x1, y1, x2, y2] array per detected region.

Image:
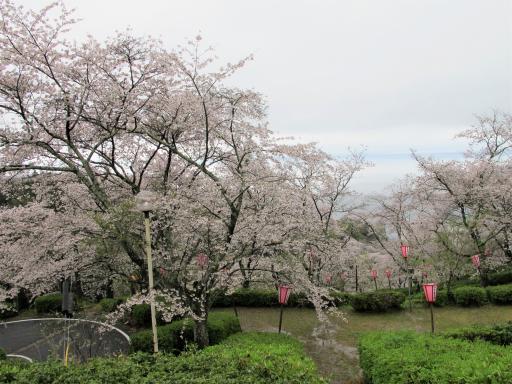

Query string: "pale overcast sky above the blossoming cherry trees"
[[15, 0, 512, 192]]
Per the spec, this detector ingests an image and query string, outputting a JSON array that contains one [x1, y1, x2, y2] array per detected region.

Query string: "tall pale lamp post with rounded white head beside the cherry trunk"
[[135, 191, 158, 353]]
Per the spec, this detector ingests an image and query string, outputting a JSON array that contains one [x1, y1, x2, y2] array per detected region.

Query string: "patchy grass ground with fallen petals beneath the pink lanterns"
[[214, 305, 512, 383]]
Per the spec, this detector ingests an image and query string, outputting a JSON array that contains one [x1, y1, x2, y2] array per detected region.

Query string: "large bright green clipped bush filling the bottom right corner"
[[359, 332, 512, 384]]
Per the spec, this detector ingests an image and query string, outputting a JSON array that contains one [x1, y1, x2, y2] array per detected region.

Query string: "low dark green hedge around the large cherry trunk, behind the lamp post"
[[131, 312, 242, 355]]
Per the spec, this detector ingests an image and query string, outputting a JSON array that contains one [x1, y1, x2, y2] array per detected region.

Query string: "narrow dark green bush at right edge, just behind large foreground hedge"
[[443, 322, 512, 345]]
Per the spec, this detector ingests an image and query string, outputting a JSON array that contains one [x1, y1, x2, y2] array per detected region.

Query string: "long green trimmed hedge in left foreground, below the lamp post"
[[0, 333, 327, 384]]
